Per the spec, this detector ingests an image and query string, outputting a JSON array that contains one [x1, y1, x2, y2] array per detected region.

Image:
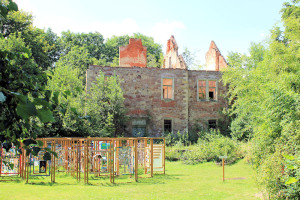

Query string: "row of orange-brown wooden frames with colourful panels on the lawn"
[[1, 137, 165, 184]]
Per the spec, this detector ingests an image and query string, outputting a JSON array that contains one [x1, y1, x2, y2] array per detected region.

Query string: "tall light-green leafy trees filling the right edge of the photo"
[[223, 0, 300, 199]]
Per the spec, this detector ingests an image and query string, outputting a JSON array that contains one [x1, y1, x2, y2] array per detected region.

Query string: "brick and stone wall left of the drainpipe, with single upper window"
[[87, 66, 188, 135]]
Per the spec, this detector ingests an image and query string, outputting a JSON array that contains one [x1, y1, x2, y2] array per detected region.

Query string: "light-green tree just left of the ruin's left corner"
[[43, 62, 87, 137]]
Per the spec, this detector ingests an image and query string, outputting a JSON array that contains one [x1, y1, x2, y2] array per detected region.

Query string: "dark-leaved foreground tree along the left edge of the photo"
[[0, 1, 58, 155]]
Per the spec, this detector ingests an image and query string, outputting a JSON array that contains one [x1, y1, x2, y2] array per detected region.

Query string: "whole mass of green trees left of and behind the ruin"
[[0, 0, 163, 146]]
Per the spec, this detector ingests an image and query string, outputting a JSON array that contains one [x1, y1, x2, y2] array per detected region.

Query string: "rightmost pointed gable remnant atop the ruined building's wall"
[[205, 41, 227, 71]]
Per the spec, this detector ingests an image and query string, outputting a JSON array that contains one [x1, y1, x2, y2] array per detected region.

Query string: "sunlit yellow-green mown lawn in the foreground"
[[0, 160, 258, 200]]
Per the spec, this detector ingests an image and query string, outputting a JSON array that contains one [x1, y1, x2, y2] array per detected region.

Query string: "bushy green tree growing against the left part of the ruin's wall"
[[86, 73, 126, 137]]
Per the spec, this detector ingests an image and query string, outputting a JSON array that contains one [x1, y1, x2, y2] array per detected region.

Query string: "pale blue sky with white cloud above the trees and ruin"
[[15, 0, 284, 64]]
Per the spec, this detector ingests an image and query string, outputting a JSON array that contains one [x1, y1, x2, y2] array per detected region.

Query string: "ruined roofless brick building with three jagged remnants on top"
[[87, 36, 227, 136]]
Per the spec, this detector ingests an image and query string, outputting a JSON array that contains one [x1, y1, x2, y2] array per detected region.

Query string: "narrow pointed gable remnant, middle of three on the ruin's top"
[[163, 35, 186, 69]]
